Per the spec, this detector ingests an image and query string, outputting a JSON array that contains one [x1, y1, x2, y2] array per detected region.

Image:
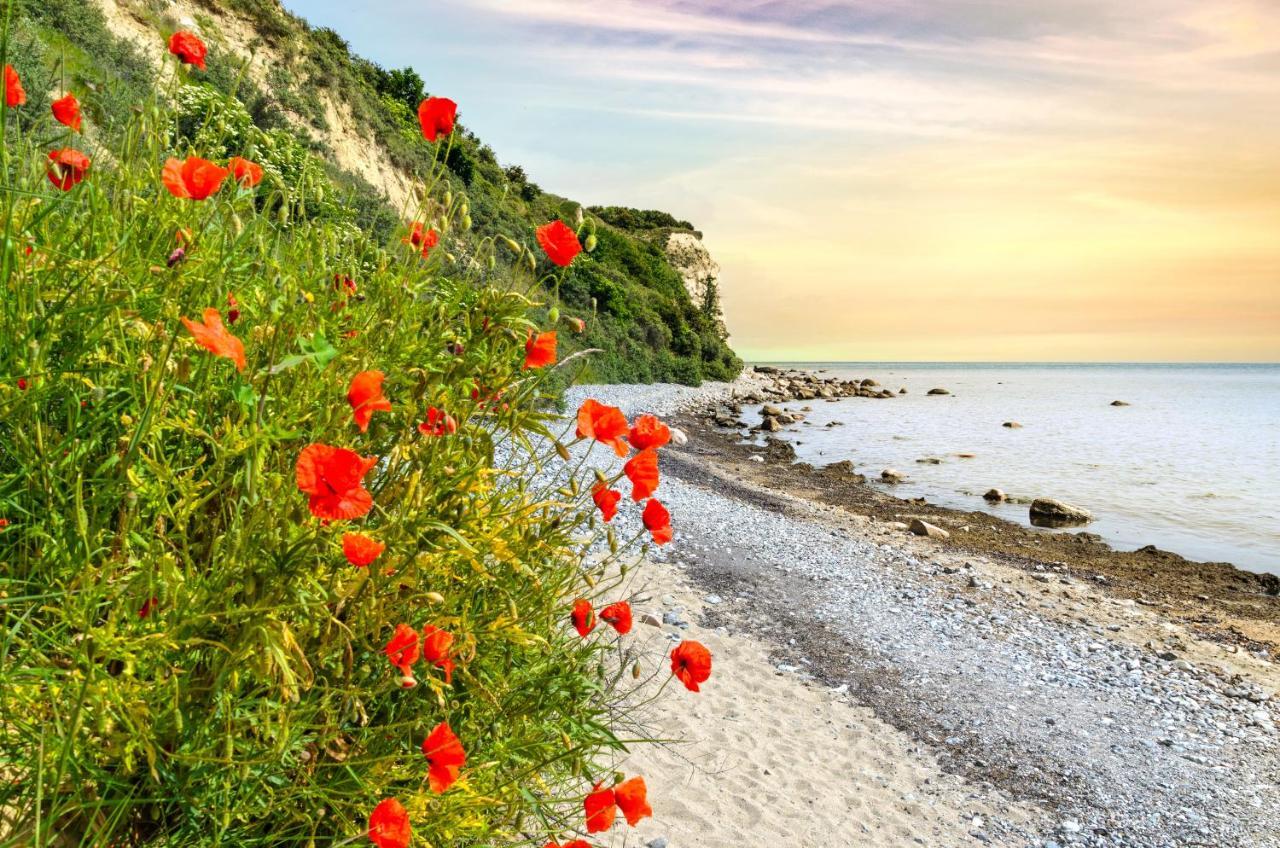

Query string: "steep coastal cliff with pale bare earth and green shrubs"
[[27, 0, 741, 384]]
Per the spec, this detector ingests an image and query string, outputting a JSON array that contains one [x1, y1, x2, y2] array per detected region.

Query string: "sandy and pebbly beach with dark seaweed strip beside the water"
[[570, 375, 1280, 848]]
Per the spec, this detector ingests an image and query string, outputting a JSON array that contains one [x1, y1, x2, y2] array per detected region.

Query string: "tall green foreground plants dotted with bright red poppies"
[[0, 14, 709, 848]]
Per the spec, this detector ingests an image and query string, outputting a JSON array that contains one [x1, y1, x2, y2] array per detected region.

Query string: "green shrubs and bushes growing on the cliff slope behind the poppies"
[[5, 0, 741, 384]]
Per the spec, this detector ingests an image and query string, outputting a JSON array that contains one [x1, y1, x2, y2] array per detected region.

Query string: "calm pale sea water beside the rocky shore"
[[751, 363, 1280, 574]]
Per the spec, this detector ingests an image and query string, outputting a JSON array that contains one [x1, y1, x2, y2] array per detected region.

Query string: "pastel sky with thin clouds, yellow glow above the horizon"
[[284, 0, 1280, 361]]
